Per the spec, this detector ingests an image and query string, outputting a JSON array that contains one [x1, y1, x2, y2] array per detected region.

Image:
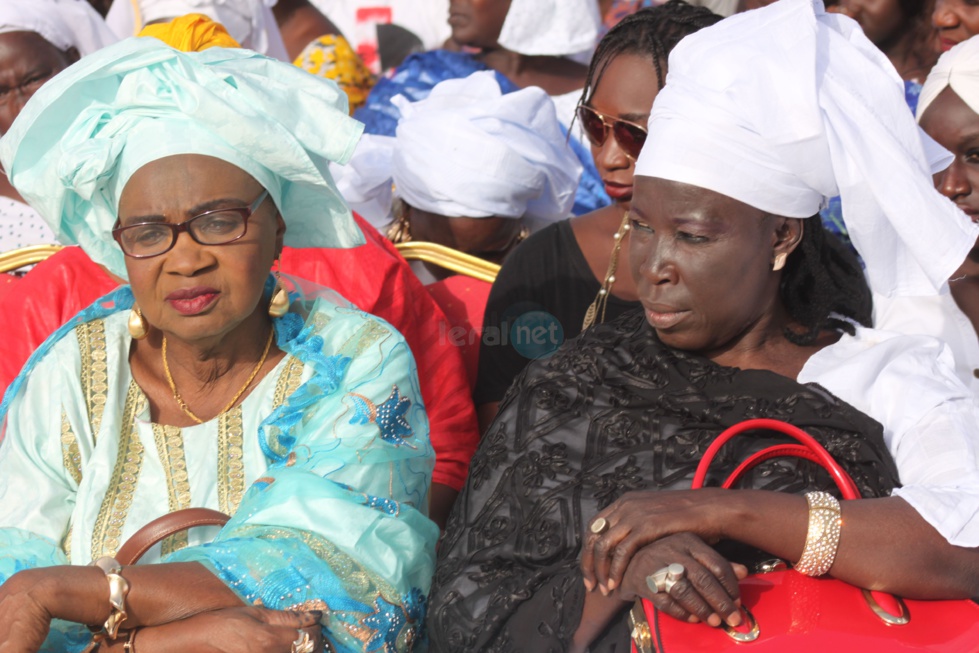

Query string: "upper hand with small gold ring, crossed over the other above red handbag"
[[581, 488, 737, 593]]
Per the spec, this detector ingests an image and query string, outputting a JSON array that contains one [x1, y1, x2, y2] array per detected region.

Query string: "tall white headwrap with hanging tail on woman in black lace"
[[636, 0, 979, 296]]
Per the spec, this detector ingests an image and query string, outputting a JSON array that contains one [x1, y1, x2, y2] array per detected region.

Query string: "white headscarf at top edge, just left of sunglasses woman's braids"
[[498, 0, 602, 63]]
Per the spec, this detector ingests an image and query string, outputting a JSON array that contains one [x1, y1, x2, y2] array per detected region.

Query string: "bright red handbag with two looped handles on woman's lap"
[[629, 419, 979, 653]]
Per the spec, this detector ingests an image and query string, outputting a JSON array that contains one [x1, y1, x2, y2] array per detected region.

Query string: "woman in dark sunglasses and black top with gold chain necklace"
[[474, 0, 720, 438]]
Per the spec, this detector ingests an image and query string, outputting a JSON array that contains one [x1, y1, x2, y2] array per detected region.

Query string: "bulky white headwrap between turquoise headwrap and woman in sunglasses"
[[332, 71, 581, 227]]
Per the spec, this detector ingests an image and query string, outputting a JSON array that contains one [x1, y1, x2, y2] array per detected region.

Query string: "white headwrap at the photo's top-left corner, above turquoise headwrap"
[[0, 0, 119, 56]]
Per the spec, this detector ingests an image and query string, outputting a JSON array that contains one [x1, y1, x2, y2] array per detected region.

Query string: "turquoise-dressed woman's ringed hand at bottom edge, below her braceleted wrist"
[[135, 607, 324, 653]]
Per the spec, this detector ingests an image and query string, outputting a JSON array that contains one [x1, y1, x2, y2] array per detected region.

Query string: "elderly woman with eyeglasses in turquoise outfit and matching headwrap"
[[0, 39, 438, 653]]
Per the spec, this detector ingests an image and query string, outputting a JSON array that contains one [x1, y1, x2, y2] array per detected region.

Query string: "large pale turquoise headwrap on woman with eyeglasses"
[[0, 38, 363, 277]]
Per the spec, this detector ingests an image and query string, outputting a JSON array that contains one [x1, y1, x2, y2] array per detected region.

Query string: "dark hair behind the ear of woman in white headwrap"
[[779, 215, 873, 345]]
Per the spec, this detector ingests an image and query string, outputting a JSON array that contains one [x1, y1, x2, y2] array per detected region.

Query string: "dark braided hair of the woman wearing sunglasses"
[[581, 0, 721, 109]]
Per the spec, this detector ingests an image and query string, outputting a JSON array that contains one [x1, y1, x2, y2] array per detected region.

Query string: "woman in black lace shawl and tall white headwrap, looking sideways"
[[429, 0, 979, 653]]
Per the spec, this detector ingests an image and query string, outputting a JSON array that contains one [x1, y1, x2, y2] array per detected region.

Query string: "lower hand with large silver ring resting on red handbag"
[[618, 533, 748, 627]]
